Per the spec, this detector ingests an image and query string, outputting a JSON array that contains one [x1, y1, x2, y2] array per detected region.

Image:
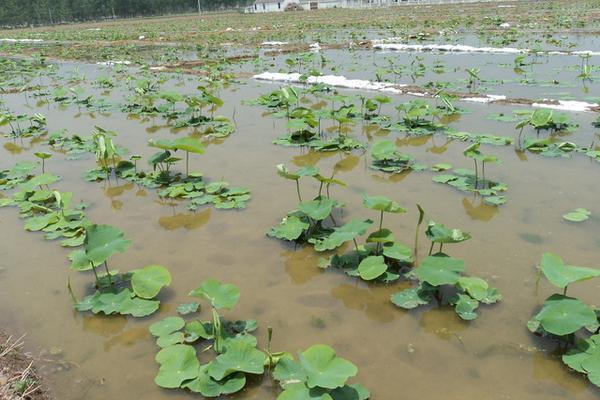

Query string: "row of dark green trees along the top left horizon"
[[0, 0, 248, 27]]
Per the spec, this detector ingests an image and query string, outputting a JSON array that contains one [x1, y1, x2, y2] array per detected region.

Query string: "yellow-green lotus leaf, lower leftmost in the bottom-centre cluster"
[[154, 344, 200, 389]]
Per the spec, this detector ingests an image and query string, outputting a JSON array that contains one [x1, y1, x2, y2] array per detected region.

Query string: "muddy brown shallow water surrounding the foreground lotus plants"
[[0, 60, 600, 400]]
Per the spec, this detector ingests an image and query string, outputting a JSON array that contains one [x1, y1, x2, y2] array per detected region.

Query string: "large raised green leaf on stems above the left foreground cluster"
[[84, 225, 131, 265]]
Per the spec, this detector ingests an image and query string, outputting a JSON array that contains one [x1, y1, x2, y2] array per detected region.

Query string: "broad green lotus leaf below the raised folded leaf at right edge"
[[531, 294, 598, 336]]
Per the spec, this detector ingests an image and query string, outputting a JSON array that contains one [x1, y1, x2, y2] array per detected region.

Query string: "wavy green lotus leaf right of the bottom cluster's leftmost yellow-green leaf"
[[208, 335, 267, 381]]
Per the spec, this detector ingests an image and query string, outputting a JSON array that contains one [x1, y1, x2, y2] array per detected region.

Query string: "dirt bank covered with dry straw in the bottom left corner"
[[0, 332, 53, 400]]
